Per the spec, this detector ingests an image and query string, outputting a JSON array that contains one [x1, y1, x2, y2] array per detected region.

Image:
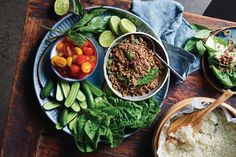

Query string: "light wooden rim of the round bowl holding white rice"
[[152, 97, 236, 157]]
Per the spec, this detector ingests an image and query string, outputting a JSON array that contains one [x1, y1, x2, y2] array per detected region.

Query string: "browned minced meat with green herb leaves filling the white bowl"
[[104, 33, 167, 98]]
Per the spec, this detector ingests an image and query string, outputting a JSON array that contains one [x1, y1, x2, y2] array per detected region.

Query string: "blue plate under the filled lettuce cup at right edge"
[[201, 27, 236, 94]]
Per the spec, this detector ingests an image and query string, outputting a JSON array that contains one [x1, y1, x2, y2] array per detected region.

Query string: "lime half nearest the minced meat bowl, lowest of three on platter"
[[99, 30, 115, 47]]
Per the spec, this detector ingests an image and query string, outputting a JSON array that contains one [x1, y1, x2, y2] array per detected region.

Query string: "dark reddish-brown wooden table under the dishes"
[[1, 0, 236, 157]]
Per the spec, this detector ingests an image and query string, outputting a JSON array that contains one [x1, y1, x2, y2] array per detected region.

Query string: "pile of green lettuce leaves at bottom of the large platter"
[[74, 97, 160, 152]]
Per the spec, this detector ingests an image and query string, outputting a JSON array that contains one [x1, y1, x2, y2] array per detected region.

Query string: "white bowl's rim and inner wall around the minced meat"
[[103, 32, 169, 101]]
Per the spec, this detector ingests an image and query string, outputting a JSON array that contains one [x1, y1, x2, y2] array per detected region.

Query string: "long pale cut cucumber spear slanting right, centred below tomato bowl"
[[65, 82, 80, 107]]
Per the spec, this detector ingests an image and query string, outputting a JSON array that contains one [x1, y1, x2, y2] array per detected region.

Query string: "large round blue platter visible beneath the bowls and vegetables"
[[33, 7, 170, 140]]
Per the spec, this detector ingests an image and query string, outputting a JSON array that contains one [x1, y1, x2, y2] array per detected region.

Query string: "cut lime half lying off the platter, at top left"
[[54, 0, 70, 16]]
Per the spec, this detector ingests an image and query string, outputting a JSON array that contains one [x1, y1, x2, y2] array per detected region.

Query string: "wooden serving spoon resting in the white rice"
[[167, 89, 233, 139]]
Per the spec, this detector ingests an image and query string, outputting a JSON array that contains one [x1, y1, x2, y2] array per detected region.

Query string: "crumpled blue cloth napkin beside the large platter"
[[132, 0, 200, 79]]
